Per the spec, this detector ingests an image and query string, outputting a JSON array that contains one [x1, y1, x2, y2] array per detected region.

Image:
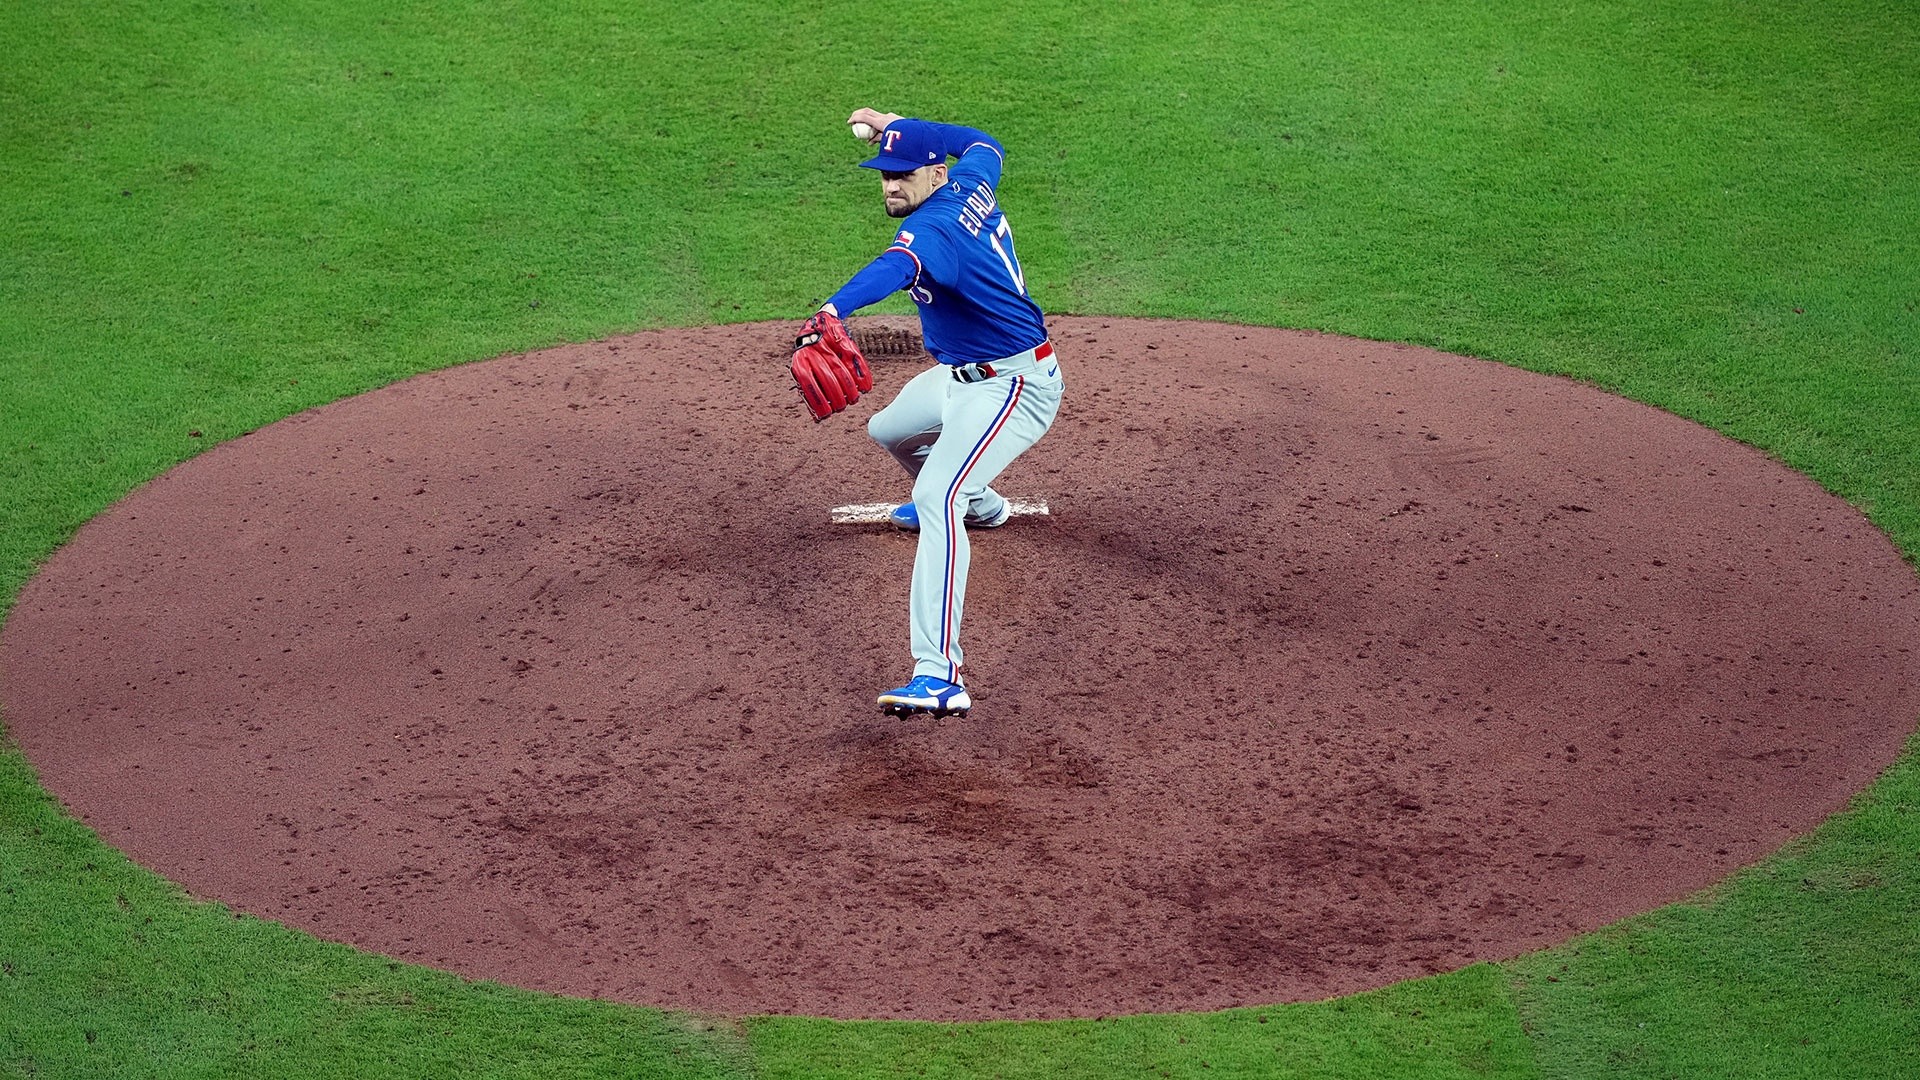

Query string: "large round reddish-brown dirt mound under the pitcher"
[[11, 319, 1920, 1019]]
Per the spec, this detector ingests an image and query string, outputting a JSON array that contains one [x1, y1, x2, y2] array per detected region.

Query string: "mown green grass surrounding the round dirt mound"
[[0, 0, 1920, 1078]]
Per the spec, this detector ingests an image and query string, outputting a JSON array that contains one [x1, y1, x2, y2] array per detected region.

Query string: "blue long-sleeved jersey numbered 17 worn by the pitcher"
[[828, 119, 1046, 365]]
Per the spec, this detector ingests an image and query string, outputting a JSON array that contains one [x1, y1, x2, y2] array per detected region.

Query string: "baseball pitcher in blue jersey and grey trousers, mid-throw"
[[793, 110, 1064, 717]]
